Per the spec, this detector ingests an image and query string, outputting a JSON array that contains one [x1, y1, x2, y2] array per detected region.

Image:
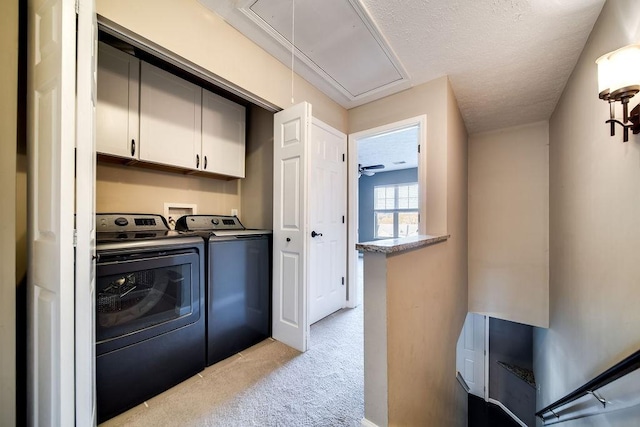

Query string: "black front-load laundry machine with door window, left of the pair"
[[95, 214, 206, 422]]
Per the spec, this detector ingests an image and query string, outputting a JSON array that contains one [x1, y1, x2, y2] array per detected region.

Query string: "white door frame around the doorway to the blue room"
[[347, 114, 427, 308]]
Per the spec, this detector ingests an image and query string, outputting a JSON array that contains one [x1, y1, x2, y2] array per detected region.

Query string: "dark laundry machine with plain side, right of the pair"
[[176, 215, 272, 366]]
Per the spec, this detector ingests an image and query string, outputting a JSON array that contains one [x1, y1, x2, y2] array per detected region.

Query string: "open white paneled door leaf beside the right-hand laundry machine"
[[272, 102, 311, 351]]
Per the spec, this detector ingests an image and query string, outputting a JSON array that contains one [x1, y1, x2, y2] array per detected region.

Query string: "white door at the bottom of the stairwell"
[[456, 313, 486, 399]]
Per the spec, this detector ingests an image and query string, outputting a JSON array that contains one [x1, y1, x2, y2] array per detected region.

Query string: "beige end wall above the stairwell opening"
[[469, 122, 549, 327]]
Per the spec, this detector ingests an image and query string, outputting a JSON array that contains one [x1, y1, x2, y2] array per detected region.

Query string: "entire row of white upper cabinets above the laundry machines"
[[96, 42, 246, 178]]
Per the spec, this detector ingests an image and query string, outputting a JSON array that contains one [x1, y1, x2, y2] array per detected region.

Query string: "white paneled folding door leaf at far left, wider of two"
[[27, 0, 76, 426]]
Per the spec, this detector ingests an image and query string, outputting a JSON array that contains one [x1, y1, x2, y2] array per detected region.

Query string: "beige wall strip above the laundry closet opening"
[[96, 0, 347, 132]]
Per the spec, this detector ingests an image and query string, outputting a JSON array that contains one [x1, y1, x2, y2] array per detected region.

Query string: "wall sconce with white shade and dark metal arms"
[[596, 44, 640, 142]]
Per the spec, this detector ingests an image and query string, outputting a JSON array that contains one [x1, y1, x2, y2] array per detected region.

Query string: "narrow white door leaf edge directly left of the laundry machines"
[[75, 0, 98, 426]]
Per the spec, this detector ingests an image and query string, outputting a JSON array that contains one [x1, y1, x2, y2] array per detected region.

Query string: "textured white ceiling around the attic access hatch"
[[200, 0, 605, 134]]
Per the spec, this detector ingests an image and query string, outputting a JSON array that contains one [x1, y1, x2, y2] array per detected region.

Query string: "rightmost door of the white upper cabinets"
[[202, 89, 246, 178]]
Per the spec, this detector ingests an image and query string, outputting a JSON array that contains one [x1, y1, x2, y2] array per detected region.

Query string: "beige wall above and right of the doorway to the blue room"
[[349, 77, 448, 234]]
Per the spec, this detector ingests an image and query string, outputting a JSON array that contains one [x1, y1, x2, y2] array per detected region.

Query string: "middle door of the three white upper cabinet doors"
[[140, 62, 203, 169]]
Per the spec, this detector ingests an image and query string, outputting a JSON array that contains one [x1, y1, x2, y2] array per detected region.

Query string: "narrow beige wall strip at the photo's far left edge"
[[0, 0, 18, 426]]
